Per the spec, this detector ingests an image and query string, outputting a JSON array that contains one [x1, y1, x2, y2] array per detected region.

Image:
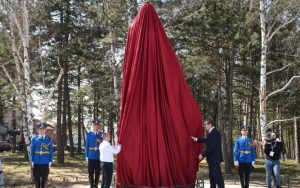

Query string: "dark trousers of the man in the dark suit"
[[208, 163, 224, 188]]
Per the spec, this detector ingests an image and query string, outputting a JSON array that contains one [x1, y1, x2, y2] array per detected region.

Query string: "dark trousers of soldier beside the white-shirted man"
[[88, 159, 101, 187]]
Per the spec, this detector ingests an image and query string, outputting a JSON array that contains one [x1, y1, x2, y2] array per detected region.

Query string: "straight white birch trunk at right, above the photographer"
[[259, 0, 268, 140]]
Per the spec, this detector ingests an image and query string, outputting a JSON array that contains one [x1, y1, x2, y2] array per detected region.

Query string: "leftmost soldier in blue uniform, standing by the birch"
[[30, 123, 53, 188]]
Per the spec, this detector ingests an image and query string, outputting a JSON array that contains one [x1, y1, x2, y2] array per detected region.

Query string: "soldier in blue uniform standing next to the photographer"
[[233, 125, 255, 188]]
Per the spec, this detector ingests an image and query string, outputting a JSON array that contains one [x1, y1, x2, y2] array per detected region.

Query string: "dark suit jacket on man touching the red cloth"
[[197, 128, 223, 164]]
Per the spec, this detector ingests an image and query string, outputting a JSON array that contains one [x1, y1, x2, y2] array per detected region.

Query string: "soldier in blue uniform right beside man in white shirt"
[[85, 119, 103, 188]]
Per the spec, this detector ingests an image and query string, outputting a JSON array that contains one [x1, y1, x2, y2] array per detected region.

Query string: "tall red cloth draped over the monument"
[[117, 3, 203, 187]]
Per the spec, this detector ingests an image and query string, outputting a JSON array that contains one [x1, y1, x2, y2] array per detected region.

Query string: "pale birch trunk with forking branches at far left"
[[7, 5, 33, 159]]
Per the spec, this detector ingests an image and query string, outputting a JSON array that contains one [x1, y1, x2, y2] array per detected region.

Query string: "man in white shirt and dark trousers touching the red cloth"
[[99, 133, 121, 188]]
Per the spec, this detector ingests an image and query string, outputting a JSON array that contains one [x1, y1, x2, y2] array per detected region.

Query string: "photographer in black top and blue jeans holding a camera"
[[264, 132, 283, 188]]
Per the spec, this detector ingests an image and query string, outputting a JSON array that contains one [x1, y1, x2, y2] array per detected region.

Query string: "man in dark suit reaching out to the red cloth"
[[191, 119, 224, 188]]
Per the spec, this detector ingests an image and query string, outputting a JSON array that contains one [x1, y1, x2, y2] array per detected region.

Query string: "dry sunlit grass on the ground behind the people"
[[2, 152, 300, 188]]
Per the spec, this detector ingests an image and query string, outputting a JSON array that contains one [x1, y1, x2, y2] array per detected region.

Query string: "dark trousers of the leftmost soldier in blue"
[[33, 164, 49, 188]]
